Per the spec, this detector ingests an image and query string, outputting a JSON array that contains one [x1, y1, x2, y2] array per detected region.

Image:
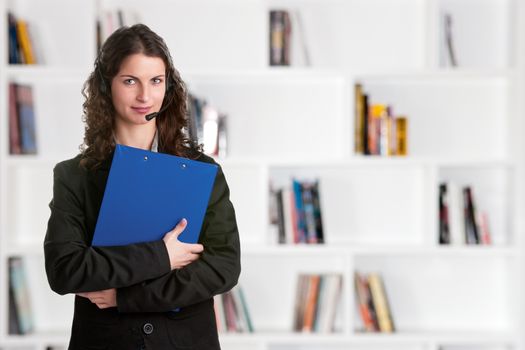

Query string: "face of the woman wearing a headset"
[[111, 53, 166, 124]]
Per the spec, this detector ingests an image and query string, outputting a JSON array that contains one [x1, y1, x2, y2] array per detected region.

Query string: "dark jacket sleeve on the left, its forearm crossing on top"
[[44, 163, 170, 294]]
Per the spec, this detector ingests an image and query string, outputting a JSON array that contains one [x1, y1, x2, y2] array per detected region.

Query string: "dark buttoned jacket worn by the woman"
[[44, 154, 240, 349]]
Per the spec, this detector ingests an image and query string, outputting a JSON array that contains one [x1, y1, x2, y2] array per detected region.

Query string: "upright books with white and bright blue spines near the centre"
[[270, 179, 324, 244]]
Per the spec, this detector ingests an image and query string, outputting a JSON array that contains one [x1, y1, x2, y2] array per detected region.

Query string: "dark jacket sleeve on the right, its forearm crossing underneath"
[[117, 167, 241, 312]]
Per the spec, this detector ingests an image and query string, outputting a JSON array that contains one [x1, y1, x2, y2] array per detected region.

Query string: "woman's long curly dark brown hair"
[[80, 24, 200, 169]]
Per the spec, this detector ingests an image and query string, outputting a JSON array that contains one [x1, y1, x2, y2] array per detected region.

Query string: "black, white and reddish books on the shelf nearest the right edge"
[[439, 182, 491, 244]]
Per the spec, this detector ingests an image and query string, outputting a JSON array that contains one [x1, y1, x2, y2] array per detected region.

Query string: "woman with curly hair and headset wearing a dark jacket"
[[44, 25, 240, 350]]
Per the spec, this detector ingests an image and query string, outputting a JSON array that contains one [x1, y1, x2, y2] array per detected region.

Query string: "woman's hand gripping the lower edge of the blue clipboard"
[[162, 219, 204, 270]]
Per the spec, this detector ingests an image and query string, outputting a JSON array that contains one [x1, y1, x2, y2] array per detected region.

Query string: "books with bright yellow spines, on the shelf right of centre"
[[354, 83, 408, 156]]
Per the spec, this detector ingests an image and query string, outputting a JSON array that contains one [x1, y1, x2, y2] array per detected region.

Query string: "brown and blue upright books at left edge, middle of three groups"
[[9, 83, 37, 154]]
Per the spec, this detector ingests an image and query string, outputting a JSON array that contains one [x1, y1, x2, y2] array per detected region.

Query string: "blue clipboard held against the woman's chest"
[[92, 145, 218, 246]]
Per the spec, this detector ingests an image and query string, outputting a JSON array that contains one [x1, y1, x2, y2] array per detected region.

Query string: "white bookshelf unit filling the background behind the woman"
[[0, 0, 525, 350]]
